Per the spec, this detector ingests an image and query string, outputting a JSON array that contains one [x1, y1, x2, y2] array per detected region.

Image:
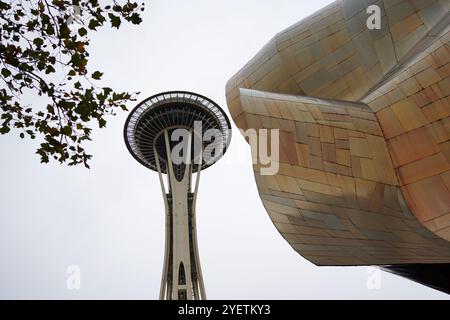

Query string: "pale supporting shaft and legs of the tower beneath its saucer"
[[155, 130, 206, 300]]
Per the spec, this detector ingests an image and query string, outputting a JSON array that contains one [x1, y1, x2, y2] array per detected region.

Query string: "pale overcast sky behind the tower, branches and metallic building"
[[0, 0, 449, 299]]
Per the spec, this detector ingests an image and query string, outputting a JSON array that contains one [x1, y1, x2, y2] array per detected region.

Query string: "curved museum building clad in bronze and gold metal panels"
[[226, 0, 450, 293]]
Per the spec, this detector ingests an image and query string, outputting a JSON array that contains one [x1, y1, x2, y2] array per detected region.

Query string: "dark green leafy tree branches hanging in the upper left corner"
[[0, 0, 144, 168]]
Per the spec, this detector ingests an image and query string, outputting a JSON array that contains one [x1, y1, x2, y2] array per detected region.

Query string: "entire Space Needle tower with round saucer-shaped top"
[[124, 91, 231, 300]]
